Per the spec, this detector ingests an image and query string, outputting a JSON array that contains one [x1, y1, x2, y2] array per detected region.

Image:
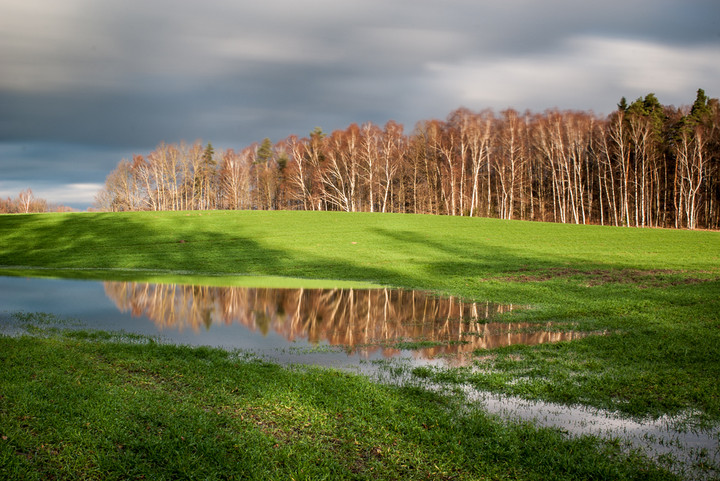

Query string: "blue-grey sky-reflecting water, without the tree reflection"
[[0, 276, 720, 479]]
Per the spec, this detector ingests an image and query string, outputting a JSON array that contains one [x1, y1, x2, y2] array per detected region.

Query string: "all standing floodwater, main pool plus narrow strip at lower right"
[[0, 277, 720, 479]]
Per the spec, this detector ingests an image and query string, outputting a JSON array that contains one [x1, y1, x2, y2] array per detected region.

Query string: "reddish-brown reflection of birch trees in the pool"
[[105, 282, 580, 357]]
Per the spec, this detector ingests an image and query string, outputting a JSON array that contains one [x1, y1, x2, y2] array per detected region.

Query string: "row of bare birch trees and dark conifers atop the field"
[[96, 89, 720, 229]]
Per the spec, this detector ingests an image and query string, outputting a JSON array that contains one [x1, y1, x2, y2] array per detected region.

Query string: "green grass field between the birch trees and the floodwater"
[[0, 211, 720, 479]]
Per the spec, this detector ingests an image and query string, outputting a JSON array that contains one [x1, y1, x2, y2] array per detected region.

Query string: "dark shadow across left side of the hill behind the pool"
[[0, 212, 442, 288]]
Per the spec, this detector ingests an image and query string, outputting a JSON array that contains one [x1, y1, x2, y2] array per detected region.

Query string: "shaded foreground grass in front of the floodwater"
[[0, 331, 673, 480]]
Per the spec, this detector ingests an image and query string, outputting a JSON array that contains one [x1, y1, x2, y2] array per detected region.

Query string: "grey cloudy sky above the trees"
[[0, 0, 720, 208]]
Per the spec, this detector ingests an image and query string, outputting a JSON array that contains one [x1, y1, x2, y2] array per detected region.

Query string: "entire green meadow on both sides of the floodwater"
[[0, 211, 720, 479]]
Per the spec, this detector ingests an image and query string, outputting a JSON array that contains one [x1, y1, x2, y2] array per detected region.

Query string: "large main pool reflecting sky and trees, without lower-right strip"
[[0, 277, 585, 366]]
